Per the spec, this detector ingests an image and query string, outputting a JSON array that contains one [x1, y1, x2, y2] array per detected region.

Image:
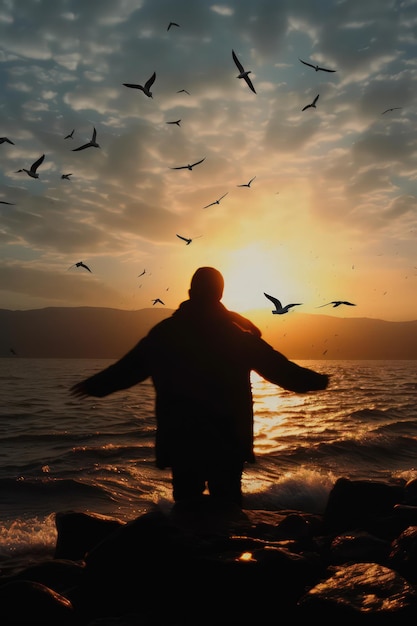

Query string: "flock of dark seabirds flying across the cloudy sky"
[[0, 22, 376, 315]]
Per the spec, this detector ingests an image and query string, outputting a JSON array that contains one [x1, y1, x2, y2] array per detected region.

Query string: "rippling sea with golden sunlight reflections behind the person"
[[0, 357, 417, 573]]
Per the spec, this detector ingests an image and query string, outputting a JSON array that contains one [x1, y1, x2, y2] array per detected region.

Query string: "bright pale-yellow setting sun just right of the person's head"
[[222, 243, 300, 313]]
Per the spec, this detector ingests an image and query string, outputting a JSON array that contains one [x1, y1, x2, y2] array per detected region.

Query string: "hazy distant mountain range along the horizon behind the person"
[[0, 307, 417, 360]]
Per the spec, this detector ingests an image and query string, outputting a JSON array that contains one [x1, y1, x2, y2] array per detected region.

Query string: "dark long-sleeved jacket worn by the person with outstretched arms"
[[74, 300, 328, 468]]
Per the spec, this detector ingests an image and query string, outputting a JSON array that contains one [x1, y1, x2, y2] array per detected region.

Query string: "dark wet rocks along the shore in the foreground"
[[0, 479, 417, 626]]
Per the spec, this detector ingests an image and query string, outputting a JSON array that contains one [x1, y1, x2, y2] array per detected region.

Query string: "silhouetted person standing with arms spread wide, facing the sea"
[[71, 267, 329, 507]]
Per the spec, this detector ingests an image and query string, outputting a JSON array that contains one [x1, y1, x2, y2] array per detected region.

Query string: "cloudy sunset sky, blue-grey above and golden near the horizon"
[[0, 0, 417, 321]]
